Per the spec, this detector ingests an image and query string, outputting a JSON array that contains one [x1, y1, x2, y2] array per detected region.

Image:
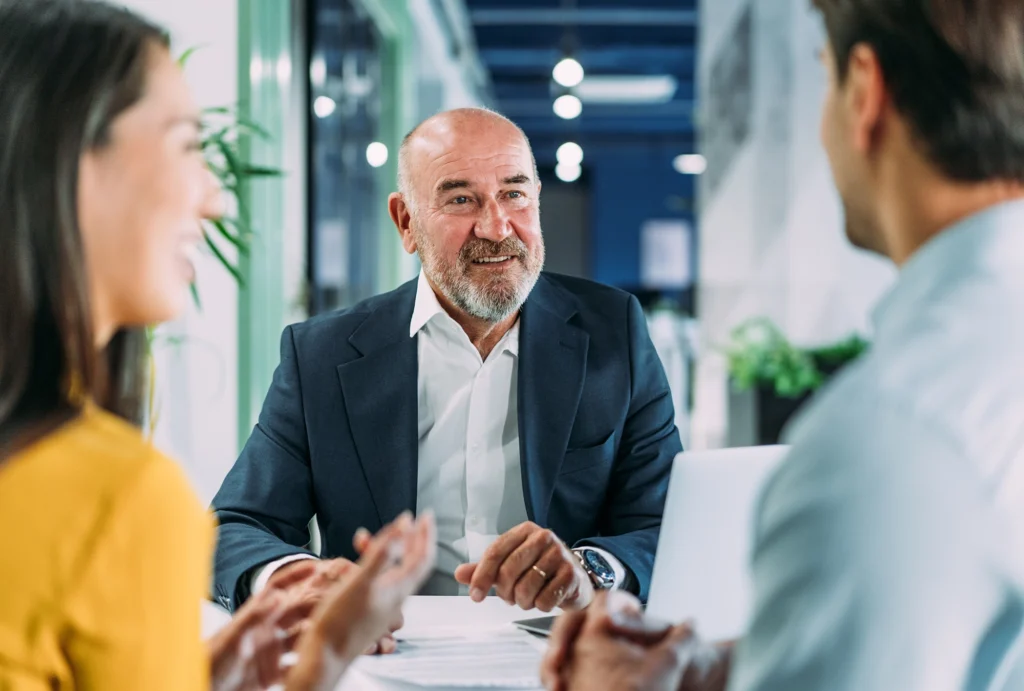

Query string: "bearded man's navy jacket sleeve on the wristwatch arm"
[[580, 297, 682, 601]]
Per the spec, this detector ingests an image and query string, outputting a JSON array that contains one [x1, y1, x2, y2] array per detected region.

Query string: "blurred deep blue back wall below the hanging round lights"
[[585, 147, 696, 288]]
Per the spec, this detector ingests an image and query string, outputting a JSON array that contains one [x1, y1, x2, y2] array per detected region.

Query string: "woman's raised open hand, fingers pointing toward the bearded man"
[[287, 513, 437, 691]]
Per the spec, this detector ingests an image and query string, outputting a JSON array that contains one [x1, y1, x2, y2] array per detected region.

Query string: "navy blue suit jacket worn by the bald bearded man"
[[213, 273, 681, 607]]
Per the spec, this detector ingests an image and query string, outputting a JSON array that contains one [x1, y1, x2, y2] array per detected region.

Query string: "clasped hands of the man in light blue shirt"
[[541, 592, 698, 691]]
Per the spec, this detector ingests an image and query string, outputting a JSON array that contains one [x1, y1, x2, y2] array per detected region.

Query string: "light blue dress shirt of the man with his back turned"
[[729, 203, 1024, 691]]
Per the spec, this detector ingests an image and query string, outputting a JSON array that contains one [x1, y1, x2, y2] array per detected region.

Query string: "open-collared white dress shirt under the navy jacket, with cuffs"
[[251, 271, 626, 595]]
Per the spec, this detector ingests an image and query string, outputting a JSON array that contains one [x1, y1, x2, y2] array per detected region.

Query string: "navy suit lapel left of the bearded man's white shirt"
[[338, 282, 419, 528]]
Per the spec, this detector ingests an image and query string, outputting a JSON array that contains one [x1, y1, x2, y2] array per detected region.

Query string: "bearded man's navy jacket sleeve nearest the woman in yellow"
[[213, 327, 315, 609]]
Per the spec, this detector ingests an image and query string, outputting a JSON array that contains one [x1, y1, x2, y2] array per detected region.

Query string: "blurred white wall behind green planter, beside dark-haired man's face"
[[693, 0, 894, 446]]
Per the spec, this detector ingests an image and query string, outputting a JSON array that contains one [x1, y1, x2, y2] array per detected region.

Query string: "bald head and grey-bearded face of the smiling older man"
[[402, 116, 544, 322]]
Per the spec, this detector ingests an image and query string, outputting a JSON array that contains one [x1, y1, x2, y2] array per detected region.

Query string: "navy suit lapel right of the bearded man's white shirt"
[[518, 275, 590, 525]]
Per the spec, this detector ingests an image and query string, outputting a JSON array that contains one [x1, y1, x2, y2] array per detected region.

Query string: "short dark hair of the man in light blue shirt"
[[812, 0, 1024, 182]]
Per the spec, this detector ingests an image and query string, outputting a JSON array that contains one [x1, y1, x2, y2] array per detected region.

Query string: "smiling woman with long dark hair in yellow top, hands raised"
[[0, 0, 433, 691]]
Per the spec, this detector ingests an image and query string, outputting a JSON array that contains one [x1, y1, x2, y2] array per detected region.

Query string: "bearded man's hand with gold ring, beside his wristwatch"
[[455, 522, 594, 612]]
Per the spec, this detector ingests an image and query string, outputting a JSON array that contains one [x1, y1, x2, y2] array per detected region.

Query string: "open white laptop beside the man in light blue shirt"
[[515, 445, 790, 641]]
